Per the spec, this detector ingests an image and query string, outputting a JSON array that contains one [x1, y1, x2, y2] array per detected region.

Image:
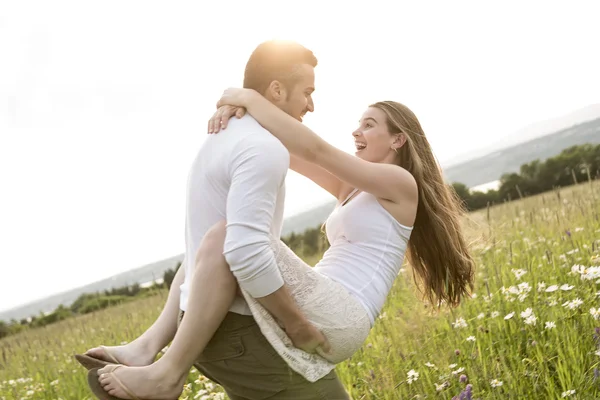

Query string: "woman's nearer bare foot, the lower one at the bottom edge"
[[98, 362, 187, 400]]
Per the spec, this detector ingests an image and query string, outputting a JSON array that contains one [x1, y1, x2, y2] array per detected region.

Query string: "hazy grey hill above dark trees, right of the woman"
[[444, 118, 600, 187]]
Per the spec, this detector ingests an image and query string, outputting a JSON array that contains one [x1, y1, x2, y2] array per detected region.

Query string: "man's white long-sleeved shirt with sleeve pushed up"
[[180, 114, 290, 315]]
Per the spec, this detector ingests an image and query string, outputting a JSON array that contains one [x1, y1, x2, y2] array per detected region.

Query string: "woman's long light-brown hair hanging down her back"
[[371, 101, 475, 307]]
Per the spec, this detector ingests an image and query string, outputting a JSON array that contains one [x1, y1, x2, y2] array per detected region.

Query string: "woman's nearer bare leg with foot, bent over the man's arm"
[[98, 221, 237, 400]]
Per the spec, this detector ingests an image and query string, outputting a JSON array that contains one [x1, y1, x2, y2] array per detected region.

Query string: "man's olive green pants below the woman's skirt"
[[179, 312, 350, 400]]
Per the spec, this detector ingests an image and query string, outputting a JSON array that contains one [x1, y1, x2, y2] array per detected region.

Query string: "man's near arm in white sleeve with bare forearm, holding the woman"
[[223, 136, 329, 351]]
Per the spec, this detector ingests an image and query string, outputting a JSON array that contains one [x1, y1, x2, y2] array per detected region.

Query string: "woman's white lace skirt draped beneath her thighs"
[[242, 239, 371, 382]]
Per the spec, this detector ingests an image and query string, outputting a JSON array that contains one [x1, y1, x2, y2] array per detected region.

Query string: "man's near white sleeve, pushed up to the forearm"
[[223, 137, 290, 298]]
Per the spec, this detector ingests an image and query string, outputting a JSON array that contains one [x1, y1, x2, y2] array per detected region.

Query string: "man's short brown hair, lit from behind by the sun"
[[244, 40, 317, 94]]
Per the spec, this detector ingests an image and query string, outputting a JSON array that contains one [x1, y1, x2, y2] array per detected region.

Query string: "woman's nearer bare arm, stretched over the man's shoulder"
[[218, 89, 416, 203]]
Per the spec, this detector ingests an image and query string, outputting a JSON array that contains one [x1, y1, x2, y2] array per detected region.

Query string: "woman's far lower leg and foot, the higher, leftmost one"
[[85, 261, 185, 366]]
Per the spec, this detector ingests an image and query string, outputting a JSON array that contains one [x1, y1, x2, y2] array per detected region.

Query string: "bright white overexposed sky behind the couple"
[[0, 0, 600, 309]]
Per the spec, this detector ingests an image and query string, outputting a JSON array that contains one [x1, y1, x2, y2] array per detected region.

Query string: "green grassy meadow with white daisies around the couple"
[[0, 184, 600, 400]]
